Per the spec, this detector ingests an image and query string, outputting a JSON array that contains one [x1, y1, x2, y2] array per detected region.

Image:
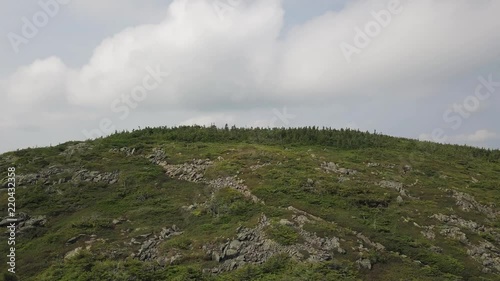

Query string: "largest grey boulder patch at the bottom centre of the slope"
[[205, 215, 345, 273]]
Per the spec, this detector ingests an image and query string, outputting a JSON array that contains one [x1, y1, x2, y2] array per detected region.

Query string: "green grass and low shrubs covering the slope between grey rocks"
[[0, 127, 500, 280]]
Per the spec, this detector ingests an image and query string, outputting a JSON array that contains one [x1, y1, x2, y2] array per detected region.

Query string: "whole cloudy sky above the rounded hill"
[[0, 0, 500, 153]]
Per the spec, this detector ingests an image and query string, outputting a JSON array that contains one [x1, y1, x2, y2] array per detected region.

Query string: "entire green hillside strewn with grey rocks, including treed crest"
[[0, 127, 500, 281]]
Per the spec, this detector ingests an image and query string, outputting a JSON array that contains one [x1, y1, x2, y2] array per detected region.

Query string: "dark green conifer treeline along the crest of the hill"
[[102, 124, 500, 162]]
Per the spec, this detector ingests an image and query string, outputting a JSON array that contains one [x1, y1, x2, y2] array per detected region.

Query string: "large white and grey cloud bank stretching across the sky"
[[0, 0, 500, 151]]
